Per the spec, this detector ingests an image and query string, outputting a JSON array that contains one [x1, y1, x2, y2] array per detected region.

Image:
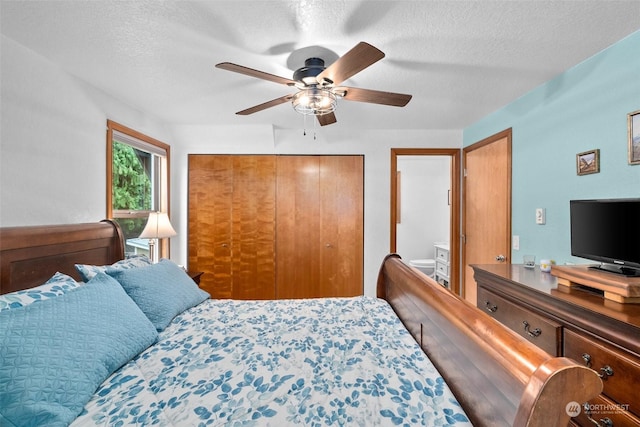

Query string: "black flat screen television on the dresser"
[[569, 199, 640, 276]]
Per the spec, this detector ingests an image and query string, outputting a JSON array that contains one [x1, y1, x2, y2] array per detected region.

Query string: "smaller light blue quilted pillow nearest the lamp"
[[107, 259, 209, 331]]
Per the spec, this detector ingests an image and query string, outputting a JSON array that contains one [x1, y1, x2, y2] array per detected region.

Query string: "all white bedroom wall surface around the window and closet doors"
[[0, 36, 462, 295]]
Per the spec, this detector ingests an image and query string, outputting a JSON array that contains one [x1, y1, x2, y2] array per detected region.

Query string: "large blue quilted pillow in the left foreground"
[[0, 273, 158, 426]]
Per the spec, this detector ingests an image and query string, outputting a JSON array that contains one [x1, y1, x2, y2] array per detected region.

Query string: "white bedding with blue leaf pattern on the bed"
[[72, 297, 471, 427]]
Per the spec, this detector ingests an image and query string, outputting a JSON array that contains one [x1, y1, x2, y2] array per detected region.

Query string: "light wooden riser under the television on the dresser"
[[551, 265, 640, 303]]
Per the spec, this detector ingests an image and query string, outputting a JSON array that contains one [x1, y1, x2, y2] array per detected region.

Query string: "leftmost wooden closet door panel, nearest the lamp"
[[188, 155, 233, 298]]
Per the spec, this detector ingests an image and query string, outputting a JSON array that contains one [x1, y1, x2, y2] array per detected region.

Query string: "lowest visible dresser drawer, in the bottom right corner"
[[571, 395, 640, 427]]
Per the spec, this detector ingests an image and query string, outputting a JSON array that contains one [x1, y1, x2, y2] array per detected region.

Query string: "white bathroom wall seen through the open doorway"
[[396, 156, 451, 260]]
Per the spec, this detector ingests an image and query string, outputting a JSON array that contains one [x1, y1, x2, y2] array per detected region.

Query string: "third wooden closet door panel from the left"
[[276, 156, 323, 299]]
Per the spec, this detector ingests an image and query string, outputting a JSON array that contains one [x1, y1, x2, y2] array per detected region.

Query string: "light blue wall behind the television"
[[463, 31, 640, 263]]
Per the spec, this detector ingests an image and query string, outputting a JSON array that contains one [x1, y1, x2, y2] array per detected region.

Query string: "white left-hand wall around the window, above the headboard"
[[0, 36, 170, 227]]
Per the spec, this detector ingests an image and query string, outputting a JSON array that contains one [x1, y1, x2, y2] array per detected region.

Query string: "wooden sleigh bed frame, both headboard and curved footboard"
[[0, 221, 602, 427]]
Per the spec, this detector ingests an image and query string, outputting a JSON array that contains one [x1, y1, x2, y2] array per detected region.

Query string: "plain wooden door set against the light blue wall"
[[462, 129, 511, 305]]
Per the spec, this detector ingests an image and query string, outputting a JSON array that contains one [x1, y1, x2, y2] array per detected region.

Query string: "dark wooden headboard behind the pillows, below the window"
[[0, 220, 124, 294]]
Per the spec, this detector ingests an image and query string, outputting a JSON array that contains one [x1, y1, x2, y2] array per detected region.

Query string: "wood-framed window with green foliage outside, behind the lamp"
[[107, 120, 170, 257]]
